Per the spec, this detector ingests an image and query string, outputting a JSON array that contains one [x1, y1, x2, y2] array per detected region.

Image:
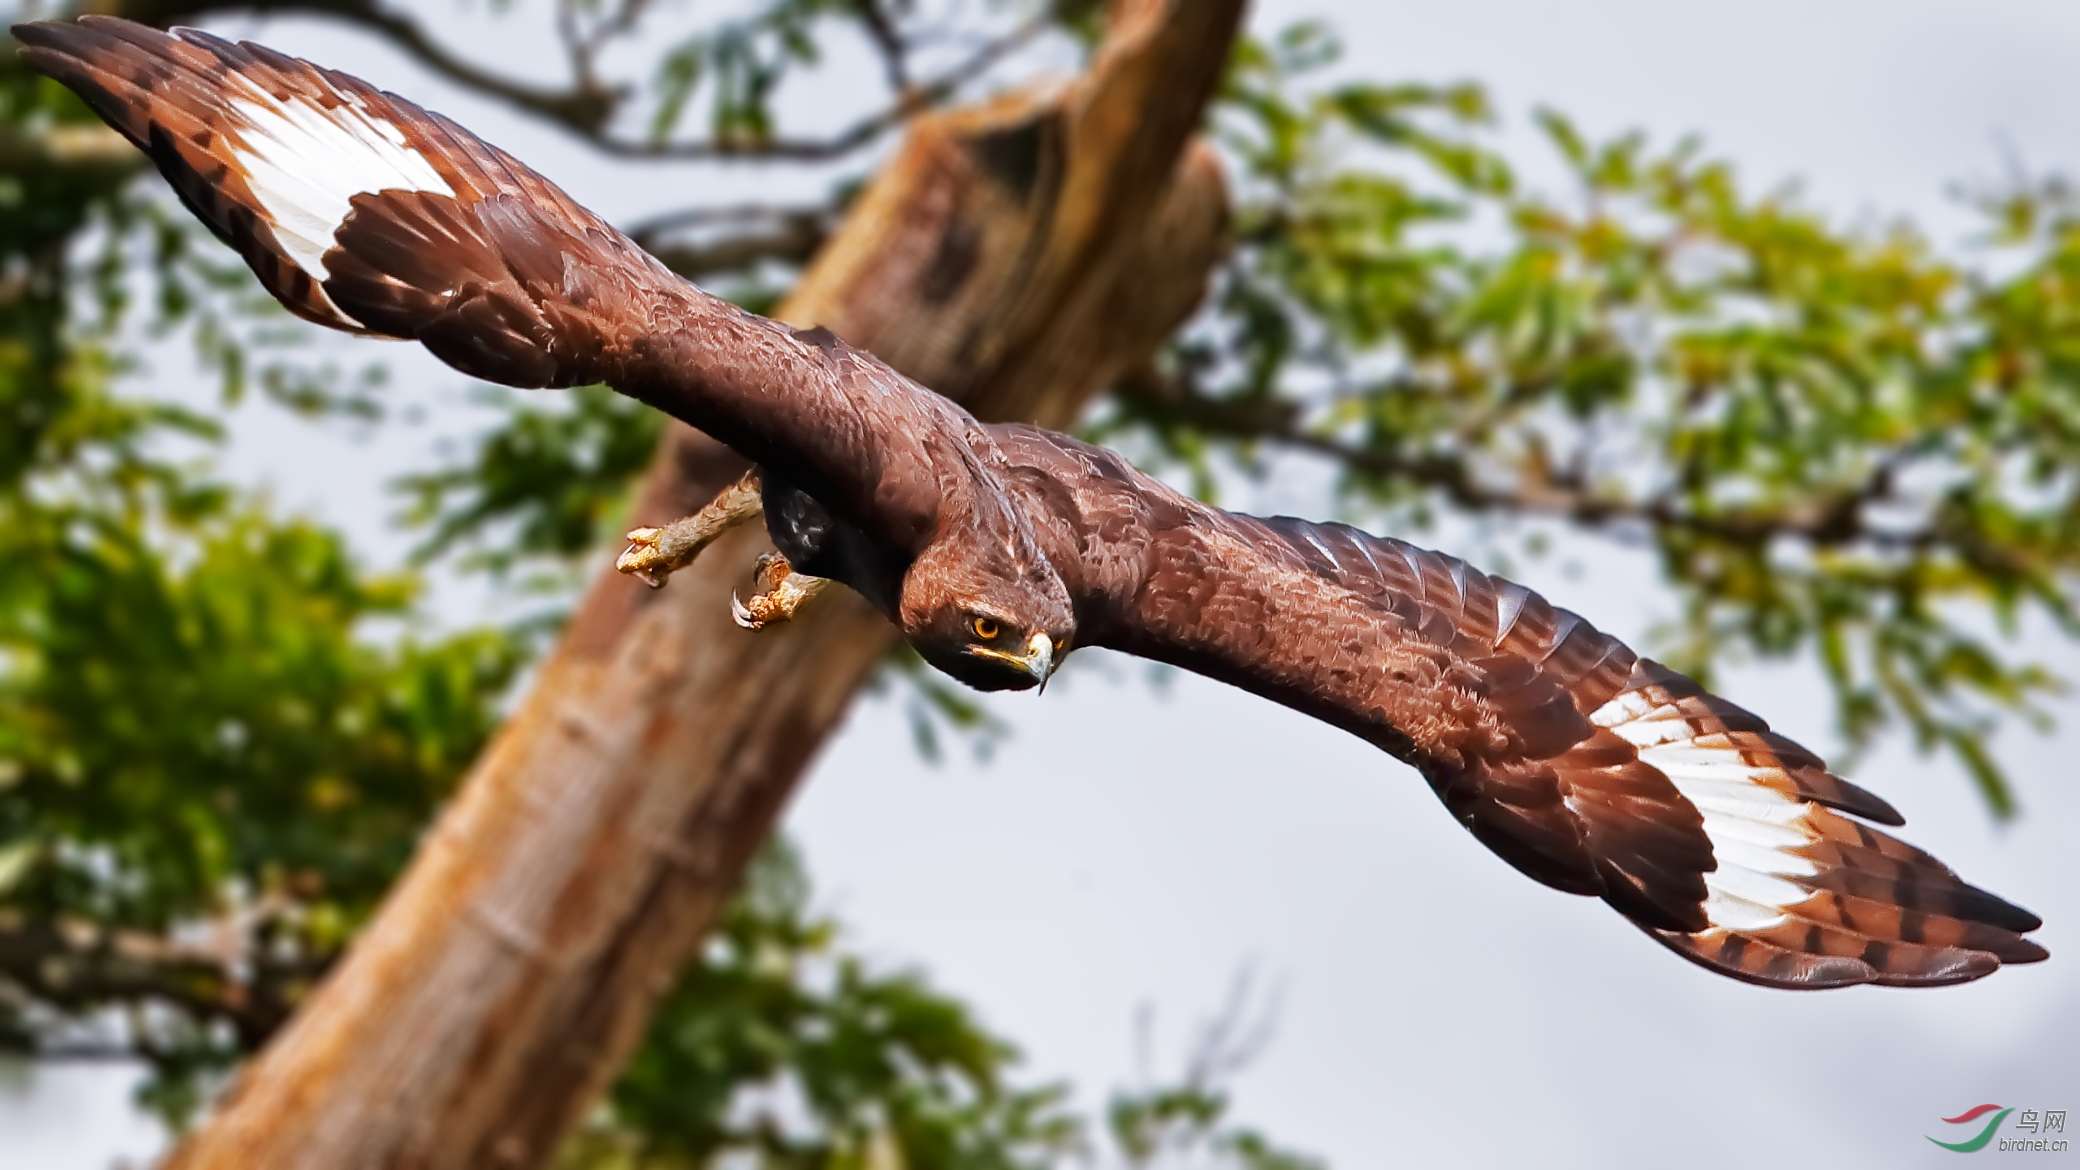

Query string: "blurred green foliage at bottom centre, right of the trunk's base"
[[564, 845, 1077, 1170]]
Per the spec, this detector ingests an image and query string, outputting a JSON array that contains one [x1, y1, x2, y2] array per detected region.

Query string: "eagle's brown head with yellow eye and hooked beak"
[[899, 520, 1075, 691]]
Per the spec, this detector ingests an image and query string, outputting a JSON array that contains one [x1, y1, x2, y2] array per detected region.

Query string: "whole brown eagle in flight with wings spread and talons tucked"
[[15, 17, 2047, 987]]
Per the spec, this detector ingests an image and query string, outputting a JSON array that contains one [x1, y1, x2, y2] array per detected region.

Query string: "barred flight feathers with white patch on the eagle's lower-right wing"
[[1214, 518, 2047, 987]]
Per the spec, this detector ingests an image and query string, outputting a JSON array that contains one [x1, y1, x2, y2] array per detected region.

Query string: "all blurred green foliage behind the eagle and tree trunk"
[[0, 0, 2080, 1170]]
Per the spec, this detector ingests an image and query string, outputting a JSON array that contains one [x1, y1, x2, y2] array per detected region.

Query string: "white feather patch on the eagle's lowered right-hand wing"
[[1589, 691, 1818, 931]]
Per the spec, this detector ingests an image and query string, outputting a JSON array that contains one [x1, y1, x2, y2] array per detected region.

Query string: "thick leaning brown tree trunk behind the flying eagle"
[[173, 0, 1242, 1170]]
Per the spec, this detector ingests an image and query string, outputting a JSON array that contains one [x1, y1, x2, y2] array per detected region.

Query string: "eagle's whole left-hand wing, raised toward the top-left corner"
[[15, 17, 969, 548]]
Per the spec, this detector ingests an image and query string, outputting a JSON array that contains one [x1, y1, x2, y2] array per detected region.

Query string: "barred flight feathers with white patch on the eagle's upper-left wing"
[[15, 17, 611, 349]]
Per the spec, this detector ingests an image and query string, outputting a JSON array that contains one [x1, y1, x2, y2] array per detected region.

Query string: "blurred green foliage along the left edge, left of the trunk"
[[0, 38, 522, 1116]]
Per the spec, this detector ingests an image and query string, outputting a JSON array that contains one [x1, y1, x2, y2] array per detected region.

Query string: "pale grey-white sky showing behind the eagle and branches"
[[0, 0, 2080, 1170]]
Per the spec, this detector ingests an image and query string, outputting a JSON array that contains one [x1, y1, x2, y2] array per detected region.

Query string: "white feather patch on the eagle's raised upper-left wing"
[[231, 75, 456, 310]]
